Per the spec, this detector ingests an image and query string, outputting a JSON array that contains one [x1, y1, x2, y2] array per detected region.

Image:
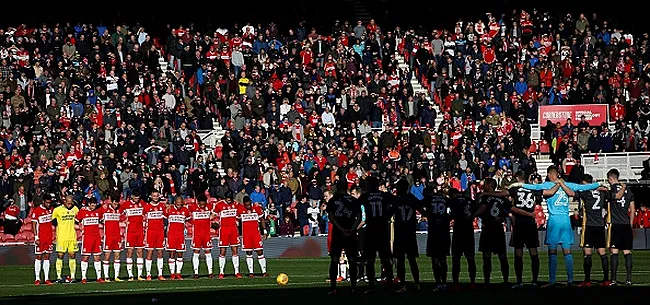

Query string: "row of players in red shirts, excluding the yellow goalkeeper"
[[29, 191, 268, 283]]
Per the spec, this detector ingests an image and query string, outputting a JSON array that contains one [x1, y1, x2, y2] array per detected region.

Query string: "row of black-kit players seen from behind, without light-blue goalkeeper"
[[325, 167, 633, 294]]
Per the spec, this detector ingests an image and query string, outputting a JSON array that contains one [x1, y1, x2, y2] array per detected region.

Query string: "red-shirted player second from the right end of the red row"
[[214, 192, 242, 279]]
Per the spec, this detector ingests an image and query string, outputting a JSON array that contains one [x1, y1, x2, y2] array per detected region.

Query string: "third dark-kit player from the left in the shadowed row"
[[393, 179, 423, 292]]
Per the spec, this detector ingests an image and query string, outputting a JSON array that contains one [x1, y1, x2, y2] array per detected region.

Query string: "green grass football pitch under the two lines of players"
[[0, 251, 650, 305]]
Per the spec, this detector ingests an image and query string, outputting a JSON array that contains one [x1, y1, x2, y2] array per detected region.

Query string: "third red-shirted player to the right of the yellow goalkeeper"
[[120, 190, 145, 281]]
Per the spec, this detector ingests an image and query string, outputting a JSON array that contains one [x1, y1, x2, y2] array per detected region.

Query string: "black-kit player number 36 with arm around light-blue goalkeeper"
[[509, 171, 560, 289]]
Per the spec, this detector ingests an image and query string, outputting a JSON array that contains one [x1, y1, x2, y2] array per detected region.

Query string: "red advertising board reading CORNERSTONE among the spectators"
[[539, 104, 609, 126]]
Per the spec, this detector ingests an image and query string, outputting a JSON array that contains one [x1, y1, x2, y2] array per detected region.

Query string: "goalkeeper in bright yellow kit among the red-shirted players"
[[52, 195, 79, 283]]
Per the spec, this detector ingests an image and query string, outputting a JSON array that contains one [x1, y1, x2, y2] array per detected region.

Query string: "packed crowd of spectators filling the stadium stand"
[[0, 10, 650, 240]]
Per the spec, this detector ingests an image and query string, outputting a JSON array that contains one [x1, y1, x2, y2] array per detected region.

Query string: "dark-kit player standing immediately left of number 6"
[[449, 188, 476, 288]]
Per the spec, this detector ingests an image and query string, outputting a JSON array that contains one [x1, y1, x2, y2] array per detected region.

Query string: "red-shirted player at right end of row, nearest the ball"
[[237, 196, 269, 278]]
